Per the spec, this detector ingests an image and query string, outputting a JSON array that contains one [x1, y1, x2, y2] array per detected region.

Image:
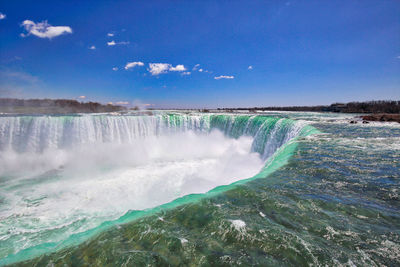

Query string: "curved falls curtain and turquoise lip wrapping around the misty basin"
[[0, 114, 319, 266]]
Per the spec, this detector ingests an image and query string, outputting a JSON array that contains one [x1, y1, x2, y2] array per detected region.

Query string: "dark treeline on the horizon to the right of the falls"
[[218, 100, 400, 113]]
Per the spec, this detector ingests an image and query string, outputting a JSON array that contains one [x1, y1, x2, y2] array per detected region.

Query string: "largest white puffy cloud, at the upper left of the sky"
[[21, 20, 72, 39]]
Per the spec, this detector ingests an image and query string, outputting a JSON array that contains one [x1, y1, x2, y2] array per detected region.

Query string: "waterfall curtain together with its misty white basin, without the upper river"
[[0, 114, 316, 262]]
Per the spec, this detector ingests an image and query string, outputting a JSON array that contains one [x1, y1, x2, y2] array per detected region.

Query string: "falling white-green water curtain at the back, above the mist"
[[0, 114, 304, 159]]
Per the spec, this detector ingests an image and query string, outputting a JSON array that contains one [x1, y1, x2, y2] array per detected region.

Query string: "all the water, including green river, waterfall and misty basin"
[[0, 112, 400, 266]]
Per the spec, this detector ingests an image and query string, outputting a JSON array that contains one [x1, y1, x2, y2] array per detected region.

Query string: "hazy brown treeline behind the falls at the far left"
[[0, 98, 126, 114]]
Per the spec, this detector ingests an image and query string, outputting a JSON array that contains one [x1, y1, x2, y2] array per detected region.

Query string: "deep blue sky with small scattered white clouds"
[[0, 0, 400, 108]]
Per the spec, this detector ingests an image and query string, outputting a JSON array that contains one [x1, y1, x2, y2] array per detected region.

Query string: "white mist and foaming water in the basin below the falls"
[[0, 131, 263, 256]]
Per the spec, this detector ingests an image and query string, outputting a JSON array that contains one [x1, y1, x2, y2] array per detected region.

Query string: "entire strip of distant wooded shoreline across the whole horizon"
[[0, 98, 400, 123]]
